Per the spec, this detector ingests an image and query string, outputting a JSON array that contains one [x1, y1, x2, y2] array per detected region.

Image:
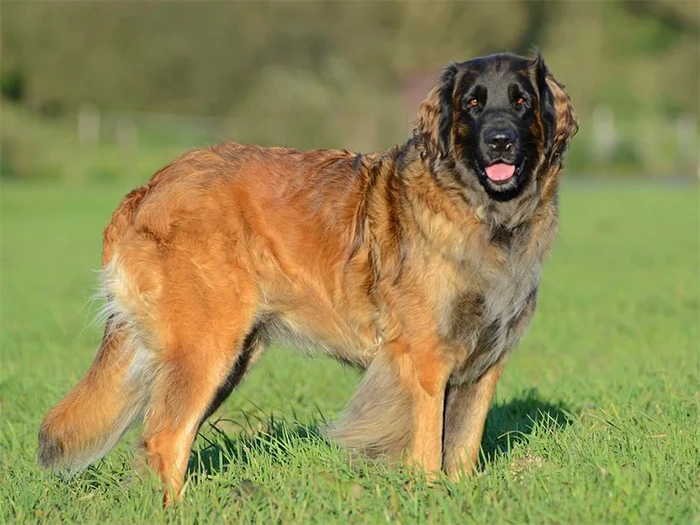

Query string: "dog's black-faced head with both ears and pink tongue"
[[416, 54, 578, 200]]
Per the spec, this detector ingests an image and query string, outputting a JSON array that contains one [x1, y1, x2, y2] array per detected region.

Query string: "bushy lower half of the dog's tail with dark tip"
[[38, 321, 150, 473]]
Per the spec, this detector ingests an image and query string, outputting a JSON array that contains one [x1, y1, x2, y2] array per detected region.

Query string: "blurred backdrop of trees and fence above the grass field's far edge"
[[0, 0, 700, 183]]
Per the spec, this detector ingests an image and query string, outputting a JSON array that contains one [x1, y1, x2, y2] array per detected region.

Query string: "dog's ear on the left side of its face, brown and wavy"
[[415, 64, 457, 158]]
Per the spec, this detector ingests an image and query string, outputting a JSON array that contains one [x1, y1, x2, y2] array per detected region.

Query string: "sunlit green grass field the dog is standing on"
[[0, 184, 700, 524]]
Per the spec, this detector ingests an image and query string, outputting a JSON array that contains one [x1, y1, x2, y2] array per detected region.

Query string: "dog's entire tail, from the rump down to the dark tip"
[[38, 176, 157, 473]]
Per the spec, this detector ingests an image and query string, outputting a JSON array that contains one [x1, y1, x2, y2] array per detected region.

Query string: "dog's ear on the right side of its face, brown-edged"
[[533, 53, 578, 158]]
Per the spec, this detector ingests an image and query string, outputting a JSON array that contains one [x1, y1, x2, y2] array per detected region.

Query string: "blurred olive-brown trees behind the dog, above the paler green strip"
[[0, 0, 700, 178]]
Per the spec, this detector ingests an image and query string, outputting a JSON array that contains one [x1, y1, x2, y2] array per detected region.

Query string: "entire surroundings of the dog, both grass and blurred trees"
[[0, 4, 700, 525]]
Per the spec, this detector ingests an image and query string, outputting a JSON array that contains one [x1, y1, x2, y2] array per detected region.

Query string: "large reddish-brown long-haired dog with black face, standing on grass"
[[38, 54, 578, 500]]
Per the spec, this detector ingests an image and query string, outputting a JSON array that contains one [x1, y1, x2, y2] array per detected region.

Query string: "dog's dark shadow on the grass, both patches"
[[188, 389, 573, 483]]
